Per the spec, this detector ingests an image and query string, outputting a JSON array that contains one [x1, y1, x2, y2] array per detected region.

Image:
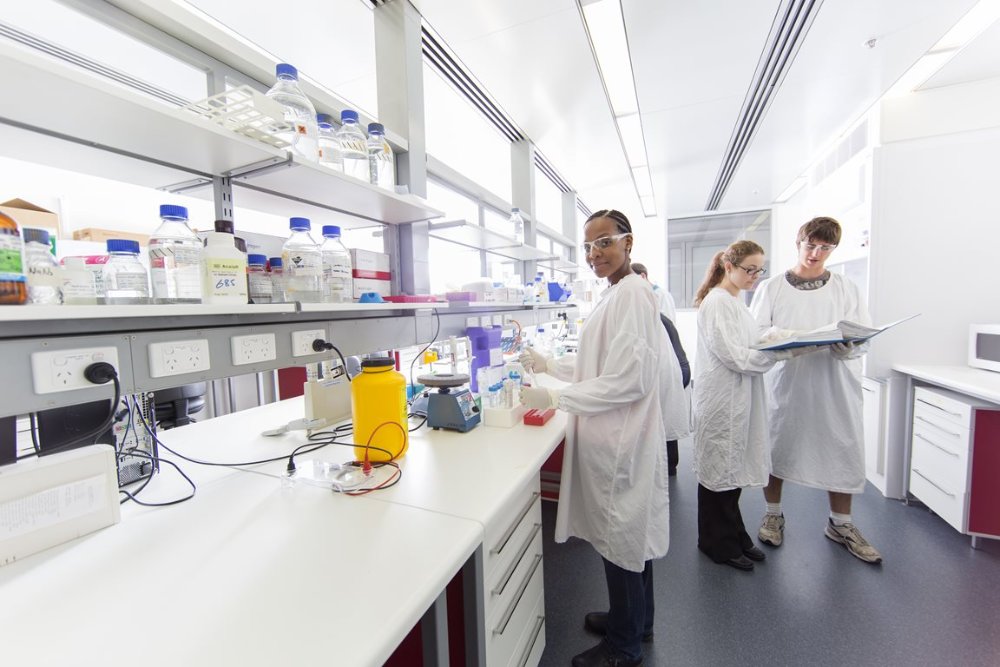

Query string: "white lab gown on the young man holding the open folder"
[[750, 273, 871, 493]]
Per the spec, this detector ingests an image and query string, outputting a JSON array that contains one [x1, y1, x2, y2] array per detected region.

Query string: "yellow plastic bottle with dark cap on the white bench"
[[351, 358, 410, 461]]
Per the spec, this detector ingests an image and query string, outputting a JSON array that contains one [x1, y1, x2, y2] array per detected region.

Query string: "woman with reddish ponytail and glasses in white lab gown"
[[694, 241, 815, 571]]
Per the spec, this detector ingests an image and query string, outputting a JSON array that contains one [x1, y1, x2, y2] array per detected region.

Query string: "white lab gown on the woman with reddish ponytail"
[[694, 287, 775, 491]]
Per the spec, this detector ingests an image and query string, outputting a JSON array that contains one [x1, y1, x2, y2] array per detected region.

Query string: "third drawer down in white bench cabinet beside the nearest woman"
[[486, 554, 543, 667]]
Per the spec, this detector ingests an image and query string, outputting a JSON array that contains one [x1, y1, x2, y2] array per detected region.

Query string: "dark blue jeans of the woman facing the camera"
[[602, 558, 653, 660]]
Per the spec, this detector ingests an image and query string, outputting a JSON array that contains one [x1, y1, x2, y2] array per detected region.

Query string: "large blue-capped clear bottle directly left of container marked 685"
[[149, 204, 204, 303]]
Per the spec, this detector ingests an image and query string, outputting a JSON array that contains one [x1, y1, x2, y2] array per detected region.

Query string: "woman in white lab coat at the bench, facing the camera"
[[522, 210, 688, 667]]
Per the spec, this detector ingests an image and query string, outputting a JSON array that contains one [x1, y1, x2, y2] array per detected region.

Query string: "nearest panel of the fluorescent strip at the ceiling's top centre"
[[581, 0, 639, 116]]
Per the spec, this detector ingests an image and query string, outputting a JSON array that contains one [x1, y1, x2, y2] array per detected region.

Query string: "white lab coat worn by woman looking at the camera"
[[548, 274, 690, 572]]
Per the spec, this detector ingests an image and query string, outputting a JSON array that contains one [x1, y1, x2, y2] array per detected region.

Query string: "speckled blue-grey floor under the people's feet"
[[541, 441, 1000, 667]]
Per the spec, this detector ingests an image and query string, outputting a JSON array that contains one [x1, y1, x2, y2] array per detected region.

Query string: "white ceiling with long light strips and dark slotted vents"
[[412, 0, 1000, 218]]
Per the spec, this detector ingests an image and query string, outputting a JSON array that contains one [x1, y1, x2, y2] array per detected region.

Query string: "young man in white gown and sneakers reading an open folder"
[[750, 217, 882, 564]]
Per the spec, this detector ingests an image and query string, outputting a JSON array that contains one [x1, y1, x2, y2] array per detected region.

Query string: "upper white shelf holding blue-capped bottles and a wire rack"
[[0, 42, 443, 224]]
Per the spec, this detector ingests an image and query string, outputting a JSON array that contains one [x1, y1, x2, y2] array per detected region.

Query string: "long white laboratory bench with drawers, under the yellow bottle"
[[0, 398, 565, 666]]
